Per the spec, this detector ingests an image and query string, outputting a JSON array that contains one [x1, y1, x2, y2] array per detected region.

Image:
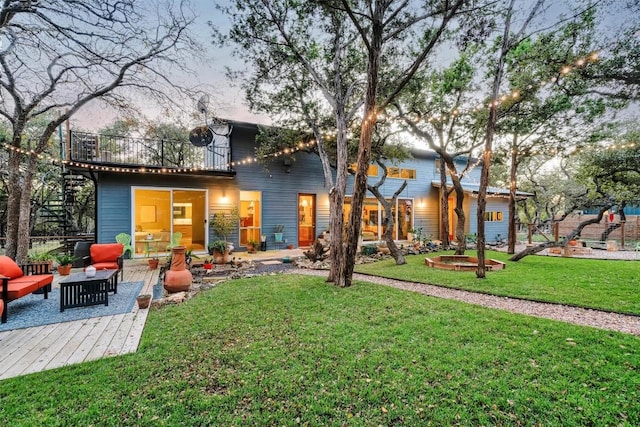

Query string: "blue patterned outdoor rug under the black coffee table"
[[0, 282, 144, 332]]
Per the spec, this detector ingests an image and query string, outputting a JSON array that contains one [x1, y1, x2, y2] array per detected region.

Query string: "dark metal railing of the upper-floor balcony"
[[69, 131, 231, 172]]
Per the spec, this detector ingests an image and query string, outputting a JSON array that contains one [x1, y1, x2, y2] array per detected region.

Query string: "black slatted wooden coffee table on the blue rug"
[[60, 270, 118, 311]]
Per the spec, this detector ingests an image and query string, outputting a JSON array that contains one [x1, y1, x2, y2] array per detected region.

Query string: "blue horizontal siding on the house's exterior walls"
[[92, 123, 508, 248]]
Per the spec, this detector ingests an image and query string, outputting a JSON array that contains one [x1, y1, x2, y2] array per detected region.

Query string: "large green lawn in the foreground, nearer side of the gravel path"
[[0, 276, 640, 426]]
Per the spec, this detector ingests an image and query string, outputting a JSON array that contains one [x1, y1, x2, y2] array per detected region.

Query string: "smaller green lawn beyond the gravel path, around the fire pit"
[[356, 251, 640, 315]]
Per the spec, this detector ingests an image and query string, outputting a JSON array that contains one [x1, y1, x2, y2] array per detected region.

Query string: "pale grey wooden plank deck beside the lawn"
[[0, 260, 160, 379]]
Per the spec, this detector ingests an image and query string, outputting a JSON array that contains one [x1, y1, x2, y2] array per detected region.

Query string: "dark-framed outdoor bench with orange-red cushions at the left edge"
[[0, 255, 53, 323]]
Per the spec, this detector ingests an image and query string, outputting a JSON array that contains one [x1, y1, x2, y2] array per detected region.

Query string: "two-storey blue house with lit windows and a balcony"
[[66, 122, 508, 256]]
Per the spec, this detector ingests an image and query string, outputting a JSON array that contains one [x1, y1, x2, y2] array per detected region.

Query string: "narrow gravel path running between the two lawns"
[[288, 269, 640, 336]]
